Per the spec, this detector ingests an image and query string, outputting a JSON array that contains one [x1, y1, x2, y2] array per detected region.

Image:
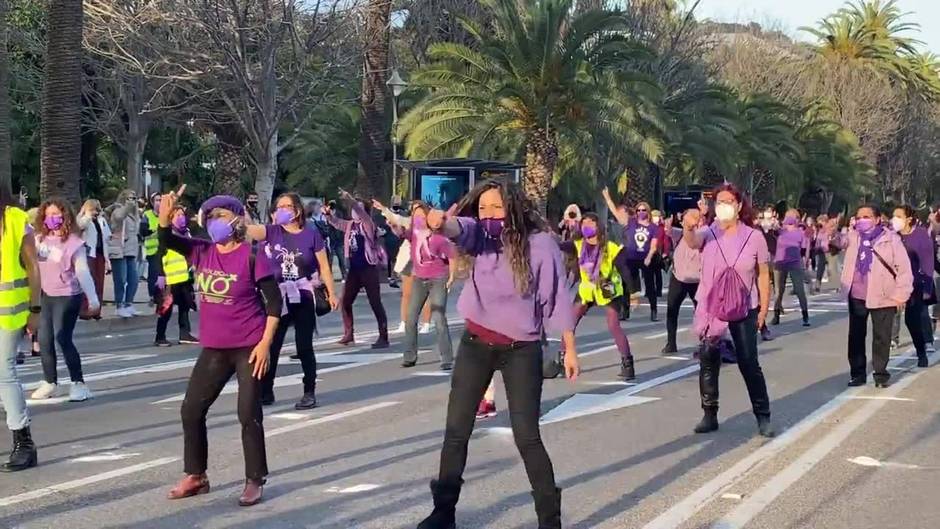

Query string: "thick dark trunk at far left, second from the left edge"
[[39, 0, 82, 205]]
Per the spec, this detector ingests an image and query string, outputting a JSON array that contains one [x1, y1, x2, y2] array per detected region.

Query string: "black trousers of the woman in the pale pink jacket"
[[849, 298, 897, 382]]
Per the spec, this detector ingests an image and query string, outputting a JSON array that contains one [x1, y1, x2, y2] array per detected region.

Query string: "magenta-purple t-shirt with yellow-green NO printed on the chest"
[[189, 239, 274, 349]]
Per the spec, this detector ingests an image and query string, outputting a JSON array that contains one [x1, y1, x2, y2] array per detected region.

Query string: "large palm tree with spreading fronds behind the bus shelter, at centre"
[[401, 0, 657, 213]]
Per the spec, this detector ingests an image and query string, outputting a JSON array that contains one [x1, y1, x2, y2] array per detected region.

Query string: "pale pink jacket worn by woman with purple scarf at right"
[[842, 230, 914, 309]]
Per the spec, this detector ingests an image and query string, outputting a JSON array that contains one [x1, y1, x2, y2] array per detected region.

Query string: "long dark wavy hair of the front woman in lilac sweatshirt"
[[457, 179, 548, 294]]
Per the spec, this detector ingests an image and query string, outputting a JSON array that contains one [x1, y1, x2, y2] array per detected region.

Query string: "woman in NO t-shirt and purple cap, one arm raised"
[[158, 185, 281, 507]]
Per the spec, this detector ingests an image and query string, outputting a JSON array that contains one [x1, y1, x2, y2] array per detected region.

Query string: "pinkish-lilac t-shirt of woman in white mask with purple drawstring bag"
[[695, 222, 768, 309]]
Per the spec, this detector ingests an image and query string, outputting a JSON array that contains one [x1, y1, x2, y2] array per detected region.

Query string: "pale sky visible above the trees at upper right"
[[686, 0, 940, 55]]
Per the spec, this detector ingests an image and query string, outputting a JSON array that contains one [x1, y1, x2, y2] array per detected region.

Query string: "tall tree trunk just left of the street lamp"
[[355, 0, 392, 197]]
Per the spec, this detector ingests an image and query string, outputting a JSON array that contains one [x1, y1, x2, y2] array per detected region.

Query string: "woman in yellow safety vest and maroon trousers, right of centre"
[[560, 213, 636, 380]]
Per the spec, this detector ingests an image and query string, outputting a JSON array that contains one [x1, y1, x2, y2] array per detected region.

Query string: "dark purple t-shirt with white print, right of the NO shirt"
[[264, 224, 326, 283]]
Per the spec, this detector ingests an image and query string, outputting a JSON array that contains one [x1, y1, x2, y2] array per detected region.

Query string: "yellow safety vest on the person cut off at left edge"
[[0, 206, 29, 331]]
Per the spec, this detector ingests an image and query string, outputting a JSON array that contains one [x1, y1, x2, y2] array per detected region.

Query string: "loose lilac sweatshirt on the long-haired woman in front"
[[447, 217, 575, 342]]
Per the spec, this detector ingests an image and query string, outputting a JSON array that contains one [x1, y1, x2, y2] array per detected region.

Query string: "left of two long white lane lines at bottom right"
[[642, 346, 933, 529]]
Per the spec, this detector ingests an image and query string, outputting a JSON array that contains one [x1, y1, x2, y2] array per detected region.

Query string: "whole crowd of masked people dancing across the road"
[[0, 181, 940, 529]]
